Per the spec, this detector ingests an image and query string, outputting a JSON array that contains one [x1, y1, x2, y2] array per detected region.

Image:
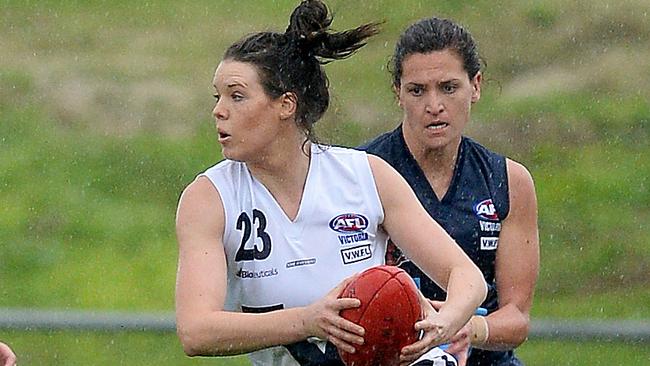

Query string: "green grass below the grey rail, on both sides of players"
[[5, 332, 650, 366]]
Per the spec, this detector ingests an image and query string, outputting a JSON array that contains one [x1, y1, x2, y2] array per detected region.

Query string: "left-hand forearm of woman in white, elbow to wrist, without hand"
[[177, 308, 308, 356]]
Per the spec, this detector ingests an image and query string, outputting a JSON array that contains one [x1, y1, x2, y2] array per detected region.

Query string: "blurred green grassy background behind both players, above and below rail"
[[0, 0, 650, 365]]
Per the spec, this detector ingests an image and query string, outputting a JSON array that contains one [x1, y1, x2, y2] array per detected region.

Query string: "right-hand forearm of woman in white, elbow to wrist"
[[440, 266, 487, 330]]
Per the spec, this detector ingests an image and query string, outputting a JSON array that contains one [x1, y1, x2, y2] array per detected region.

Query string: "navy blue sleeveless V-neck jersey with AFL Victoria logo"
[[360, 126, 520, 366]]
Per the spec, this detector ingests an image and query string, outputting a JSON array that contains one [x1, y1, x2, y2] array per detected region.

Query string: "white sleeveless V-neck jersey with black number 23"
[[204, 144, 387, 366]]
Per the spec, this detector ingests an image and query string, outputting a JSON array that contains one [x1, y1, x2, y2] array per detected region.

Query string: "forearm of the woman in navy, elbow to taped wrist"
[[472, 305, 530, 351]]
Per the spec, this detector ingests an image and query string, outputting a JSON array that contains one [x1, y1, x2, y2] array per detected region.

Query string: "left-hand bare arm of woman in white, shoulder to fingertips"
[[176, 177, 363, 356]]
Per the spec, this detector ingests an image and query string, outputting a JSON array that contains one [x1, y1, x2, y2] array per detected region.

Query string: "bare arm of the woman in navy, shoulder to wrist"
[[478, 160, 539, 350]]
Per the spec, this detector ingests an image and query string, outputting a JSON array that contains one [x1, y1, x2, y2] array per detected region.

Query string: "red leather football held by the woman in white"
[[339, 266, 422, 366]]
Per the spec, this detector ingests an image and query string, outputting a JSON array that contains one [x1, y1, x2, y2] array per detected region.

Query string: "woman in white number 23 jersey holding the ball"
[[176, 0, 486, 366]]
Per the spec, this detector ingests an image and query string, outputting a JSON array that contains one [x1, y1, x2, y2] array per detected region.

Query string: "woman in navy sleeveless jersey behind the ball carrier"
[[362, 18, 539, 366]]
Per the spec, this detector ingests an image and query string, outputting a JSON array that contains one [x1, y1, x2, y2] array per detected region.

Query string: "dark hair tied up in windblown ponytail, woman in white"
[[224, 0, 379, 141]]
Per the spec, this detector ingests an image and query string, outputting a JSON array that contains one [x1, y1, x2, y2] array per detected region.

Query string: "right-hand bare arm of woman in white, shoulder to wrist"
[[368, 156, 487, 348]]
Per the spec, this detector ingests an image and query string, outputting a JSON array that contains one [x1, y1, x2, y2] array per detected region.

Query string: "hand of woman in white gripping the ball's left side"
[[303, 276, 365, 353]]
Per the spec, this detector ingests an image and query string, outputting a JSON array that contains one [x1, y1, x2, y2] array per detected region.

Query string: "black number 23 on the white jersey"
[[235, 209, 271, 262]]
